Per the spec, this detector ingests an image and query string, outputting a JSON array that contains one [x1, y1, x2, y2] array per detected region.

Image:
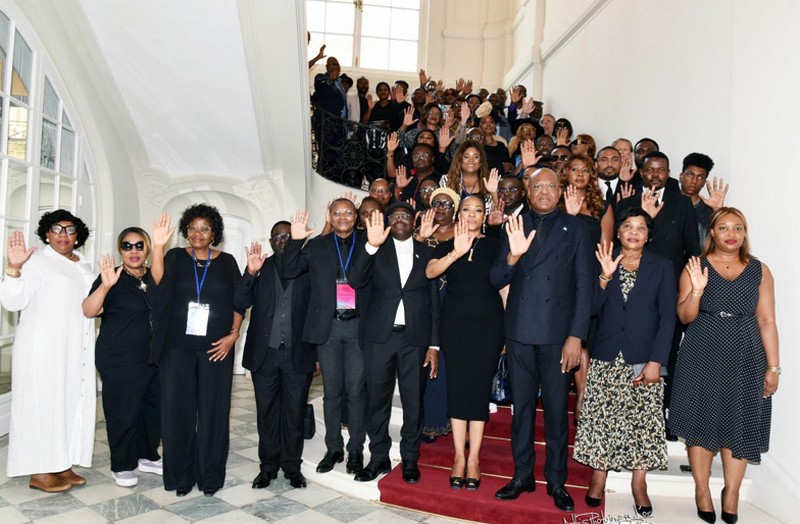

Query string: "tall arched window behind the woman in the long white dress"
[[0, 8, 96, 418]]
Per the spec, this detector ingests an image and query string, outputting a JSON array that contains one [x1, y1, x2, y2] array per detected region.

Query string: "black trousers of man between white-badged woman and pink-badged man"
[[252, 346, 314, 474]]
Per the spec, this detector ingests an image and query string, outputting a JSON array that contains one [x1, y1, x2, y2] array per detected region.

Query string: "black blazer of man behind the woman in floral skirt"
[[615, 191, 700, 278]]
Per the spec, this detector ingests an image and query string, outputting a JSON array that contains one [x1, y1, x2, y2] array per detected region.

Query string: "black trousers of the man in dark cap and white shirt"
[[364, 331, 428, 461]]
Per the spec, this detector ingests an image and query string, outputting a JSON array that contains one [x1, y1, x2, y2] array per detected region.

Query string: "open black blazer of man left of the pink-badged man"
[[233, 256, 317, 373]]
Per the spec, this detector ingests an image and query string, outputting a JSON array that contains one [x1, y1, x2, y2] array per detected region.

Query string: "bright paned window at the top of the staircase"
[[306, 0, 420, 72]]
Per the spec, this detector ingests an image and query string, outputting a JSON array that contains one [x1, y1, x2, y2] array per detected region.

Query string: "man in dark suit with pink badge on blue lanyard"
[[278, 203, 366, 473]]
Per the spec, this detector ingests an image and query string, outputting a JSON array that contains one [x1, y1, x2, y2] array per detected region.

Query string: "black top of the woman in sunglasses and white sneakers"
[[89, 268, 156, 366]]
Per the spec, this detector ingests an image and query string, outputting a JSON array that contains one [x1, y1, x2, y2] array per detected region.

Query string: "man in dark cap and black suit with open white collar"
[[350, 202, 439, 483]]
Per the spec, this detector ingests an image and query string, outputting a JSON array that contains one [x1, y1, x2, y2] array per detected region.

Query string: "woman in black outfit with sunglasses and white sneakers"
[[83, 227, 162, 487]]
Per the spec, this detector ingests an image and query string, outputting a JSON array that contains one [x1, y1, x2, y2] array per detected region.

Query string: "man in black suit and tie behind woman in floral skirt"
[[615, 151, 700, 280]]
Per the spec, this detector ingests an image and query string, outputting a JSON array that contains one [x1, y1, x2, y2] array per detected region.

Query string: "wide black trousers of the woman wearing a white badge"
[[159, 348, 233, 491]]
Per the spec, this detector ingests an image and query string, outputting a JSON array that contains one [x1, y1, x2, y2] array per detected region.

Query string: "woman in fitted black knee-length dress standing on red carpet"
[[425, 196, 503, 490]]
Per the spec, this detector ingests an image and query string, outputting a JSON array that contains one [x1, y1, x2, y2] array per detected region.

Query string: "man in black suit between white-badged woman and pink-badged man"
[[233, 221, 317, 488]]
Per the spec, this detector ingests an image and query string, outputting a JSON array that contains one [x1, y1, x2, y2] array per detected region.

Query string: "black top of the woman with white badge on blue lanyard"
[[159, 247, 244, 350]]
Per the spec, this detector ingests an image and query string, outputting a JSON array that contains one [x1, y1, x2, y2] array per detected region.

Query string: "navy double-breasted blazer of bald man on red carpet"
[[490, 208, 597, 345]]
